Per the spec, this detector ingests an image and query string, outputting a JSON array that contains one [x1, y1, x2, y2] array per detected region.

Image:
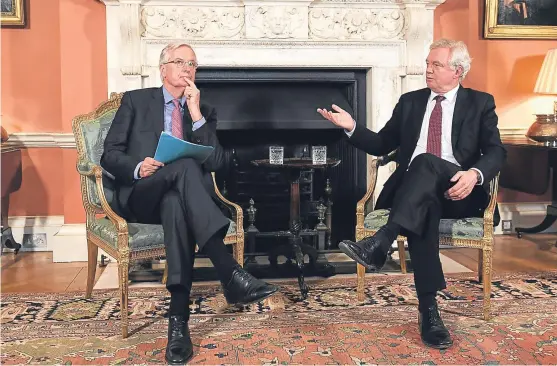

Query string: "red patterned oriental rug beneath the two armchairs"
[[0, 272, 557, 365]]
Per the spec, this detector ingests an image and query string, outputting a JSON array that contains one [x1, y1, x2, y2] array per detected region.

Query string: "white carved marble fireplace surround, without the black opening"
[[102, 0, 445, 189]]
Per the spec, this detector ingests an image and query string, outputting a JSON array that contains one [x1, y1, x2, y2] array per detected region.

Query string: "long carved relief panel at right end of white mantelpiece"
[[309, 8, 404, 40]]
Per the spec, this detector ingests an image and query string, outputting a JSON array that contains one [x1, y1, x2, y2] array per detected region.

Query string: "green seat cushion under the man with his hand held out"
[[364, 209, 484, 239]]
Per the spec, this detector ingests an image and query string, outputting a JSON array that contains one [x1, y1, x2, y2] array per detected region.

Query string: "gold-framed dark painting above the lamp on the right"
[[484, 0, 557, 39]]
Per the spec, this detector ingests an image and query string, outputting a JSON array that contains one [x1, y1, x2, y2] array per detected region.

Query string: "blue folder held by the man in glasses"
[[153, 131, 215, 164]]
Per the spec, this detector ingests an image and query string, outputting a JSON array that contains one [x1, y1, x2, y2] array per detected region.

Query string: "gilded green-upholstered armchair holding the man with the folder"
[[72, 93, 244, 338]]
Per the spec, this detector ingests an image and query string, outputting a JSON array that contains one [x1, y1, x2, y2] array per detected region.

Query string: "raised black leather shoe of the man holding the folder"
[[223, 266, 278, 305]]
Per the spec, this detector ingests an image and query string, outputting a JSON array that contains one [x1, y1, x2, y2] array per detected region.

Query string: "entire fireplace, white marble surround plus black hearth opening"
[[101, 0, 445, 278]]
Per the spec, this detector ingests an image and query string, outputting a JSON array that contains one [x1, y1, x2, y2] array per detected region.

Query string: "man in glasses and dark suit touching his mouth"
[[101, 44, 278, 364]]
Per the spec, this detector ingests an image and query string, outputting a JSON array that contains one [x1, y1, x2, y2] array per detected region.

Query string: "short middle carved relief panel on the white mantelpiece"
[[246, 6, 308, 39]]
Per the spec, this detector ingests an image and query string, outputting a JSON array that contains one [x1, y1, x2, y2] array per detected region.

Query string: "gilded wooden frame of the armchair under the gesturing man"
[[356, 152, 499, 320]]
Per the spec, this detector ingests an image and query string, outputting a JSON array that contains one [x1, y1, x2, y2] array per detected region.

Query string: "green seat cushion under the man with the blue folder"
[[89, 218, 236, 252]]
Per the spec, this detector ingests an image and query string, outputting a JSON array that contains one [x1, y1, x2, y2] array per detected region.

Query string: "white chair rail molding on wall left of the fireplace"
[[2, 132, 76, 151]]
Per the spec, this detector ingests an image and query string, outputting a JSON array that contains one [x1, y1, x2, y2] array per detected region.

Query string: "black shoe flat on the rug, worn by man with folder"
[[164, 315, 193, 365]]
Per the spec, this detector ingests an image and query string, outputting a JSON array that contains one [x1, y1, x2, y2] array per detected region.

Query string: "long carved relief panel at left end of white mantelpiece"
[[141, 6, 244, 39]]
